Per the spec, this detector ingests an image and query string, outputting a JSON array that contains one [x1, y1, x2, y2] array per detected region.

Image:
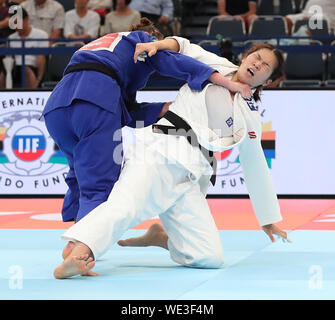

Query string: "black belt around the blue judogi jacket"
[[64, 62, 141, 111]]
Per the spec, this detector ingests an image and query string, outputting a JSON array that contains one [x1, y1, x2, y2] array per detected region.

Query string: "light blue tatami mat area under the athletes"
[[0, 229, 335, 300]]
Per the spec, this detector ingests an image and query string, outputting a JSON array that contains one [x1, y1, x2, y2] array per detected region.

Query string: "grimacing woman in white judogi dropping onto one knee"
[[54, 37, 287, 278]]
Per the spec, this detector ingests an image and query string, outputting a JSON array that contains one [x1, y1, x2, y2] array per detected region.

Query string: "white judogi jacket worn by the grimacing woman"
[[136, 37, 282, 226]]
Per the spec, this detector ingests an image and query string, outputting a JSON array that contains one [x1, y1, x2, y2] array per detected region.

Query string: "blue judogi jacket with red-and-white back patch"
[[43, 31, 216, 127]]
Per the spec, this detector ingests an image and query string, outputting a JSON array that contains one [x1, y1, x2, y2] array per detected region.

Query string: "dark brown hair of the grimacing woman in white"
[[243, 43, 285, 101]]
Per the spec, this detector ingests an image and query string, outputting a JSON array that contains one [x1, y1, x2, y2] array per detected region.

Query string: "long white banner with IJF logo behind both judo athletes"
[[0, 90, 335, 195]]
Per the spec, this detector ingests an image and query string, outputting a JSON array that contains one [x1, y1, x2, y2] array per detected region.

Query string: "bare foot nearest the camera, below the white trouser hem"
[[54, 254, 98, 279]]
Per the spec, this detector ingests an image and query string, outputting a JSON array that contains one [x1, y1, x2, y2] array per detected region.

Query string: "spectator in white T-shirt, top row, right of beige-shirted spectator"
[[64, 0, 100, 39]]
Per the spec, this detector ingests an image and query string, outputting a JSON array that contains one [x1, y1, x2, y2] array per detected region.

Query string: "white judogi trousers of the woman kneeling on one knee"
[[62, 143, 223, 268]]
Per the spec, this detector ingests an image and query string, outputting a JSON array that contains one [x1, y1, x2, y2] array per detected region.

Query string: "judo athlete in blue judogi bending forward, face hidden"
[[43, 19, 251, 228]]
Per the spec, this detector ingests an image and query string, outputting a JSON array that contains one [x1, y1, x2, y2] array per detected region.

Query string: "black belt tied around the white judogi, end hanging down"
[[152, 110, 217, 186]]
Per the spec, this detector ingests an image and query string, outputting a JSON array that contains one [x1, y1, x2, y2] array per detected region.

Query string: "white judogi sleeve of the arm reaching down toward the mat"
[[239, 136, 282, 226]]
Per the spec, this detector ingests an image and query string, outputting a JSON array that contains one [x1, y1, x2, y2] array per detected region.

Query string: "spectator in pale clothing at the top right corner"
[[285, 0, 335, 34]]
